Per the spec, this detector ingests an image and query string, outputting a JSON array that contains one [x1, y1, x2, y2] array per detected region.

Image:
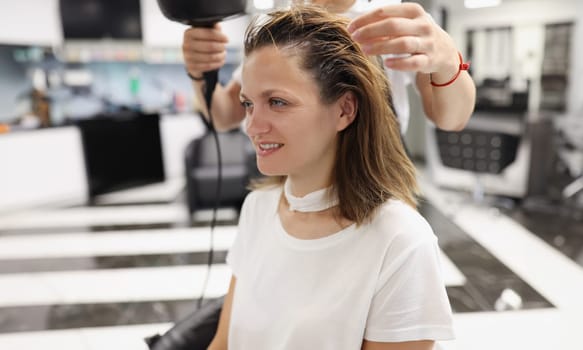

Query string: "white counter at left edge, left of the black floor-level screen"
[[0, 127, 88, 213]]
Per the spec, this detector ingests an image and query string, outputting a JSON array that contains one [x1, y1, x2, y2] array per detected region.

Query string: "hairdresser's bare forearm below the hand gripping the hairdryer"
[[192, 81, 245, 131]]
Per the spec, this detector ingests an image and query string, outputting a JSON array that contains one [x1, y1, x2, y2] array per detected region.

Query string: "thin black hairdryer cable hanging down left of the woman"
[[197, 71, 223, 309]]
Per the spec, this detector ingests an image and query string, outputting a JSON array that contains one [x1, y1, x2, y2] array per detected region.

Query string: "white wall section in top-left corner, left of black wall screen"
[[0, 0, 63, 46]]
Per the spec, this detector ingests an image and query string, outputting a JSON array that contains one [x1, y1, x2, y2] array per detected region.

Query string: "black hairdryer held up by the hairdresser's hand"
[[158, 0, 247, 123]]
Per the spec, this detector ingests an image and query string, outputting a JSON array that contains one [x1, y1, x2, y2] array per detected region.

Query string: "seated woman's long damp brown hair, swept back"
[[245, 5, 417, 224]]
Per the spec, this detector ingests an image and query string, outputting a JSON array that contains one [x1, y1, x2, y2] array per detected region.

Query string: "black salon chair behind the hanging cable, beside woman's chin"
[[185, 129, 258, 214]]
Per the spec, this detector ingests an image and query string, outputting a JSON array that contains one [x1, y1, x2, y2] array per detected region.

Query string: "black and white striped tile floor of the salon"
[[0, 176, 583, 350]]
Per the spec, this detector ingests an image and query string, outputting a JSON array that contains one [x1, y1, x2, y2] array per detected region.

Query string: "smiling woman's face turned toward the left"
[[241, 46, 352, 186]]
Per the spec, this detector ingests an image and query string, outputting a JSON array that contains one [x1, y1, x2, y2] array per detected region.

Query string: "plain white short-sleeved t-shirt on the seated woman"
[[227, 187, 453, 350]]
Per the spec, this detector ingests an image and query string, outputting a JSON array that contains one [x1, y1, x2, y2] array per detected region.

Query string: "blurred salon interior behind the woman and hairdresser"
[[0, 0, 583, 350]]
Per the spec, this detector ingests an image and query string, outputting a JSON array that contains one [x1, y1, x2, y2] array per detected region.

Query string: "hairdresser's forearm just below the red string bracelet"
[[417, 71, 476, 131]]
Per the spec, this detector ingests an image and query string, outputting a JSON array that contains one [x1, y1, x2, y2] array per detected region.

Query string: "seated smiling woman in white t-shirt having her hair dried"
[[209, 7, 453, 350]]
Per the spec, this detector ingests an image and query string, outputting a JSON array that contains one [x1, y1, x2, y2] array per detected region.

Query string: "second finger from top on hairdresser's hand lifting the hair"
[[352, 17, 426, 44]]
